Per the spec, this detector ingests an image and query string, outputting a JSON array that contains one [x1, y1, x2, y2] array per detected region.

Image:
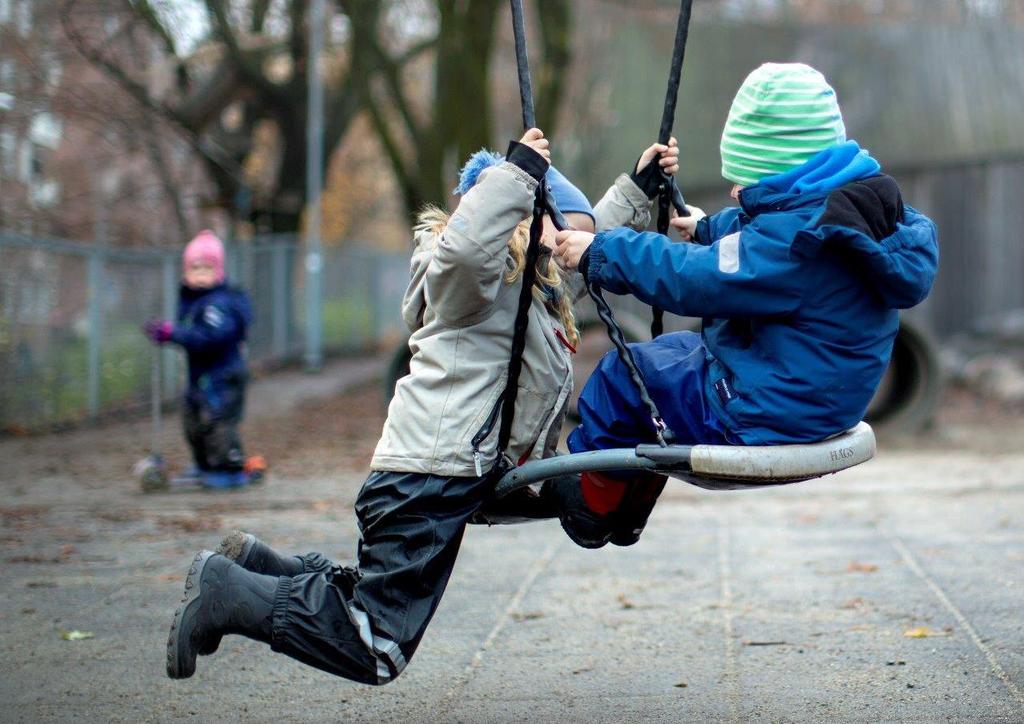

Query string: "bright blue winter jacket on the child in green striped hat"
[[588, 141, 938, 444]]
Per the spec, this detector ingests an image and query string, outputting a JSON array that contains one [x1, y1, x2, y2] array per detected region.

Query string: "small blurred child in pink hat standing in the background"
[[144, 230, 252, 487]]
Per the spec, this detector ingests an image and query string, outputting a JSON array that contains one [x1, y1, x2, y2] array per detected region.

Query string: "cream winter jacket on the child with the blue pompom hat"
[[371, 162, 650, 477]]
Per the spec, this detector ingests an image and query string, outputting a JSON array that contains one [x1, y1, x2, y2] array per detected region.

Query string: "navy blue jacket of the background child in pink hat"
[[171, 283, 252, 397]]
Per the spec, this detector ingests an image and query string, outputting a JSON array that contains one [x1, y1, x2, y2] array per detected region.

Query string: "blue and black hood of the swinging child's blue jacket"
[[740, 141, 939, 309]]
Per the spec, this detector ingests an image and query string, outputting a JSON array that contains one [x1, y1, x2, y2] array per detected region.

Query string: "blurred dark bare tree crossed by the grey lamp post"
[[60, 0, 368, 230]]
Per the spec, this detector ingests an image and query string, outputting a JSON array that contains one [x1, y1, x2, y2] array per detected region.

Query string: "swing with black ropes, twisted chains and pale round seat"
[[483, 0, 876, 499]]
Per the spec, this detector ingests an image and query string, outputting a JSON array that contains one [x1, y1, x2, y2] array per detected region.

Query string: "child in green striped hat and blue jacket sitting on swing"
[[547, 63, 938, 548]]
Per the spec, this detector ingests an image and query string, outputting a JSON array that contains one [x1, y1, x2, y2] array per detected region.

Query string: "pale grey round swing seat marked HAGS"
[[495, 422, 874, 498]]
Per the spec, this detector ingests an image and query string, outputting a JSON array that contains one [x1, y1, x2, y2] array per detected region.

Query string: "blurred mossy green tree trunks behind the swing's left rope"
[[338, 0, 570, 215]]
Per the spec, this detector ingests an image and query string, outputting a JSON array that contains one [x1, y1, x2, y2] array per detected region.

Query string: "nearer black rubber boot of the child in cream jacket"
[[167, 551, 278, 679]]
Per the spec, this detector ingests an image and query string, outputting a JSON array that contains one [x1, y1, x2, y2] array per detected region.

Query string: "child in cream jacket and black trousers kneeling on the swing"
[[167, 129, 676, 684]]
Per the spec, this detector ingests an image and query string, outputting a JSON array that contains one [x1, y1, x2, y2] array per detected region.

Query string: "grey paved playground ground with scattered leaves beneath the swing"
[[0, 358, 1024, 722]]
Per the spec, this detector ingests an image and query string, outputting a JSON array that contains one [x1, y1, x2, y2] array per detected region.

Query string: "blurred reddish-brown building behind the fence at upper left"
[[0, 0, 208, 247]]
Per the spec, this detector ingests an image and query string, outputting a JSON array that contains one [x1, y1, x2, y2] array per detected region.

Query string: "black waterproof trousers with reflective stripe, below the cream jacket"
[[271, 472, 490, 684]]
